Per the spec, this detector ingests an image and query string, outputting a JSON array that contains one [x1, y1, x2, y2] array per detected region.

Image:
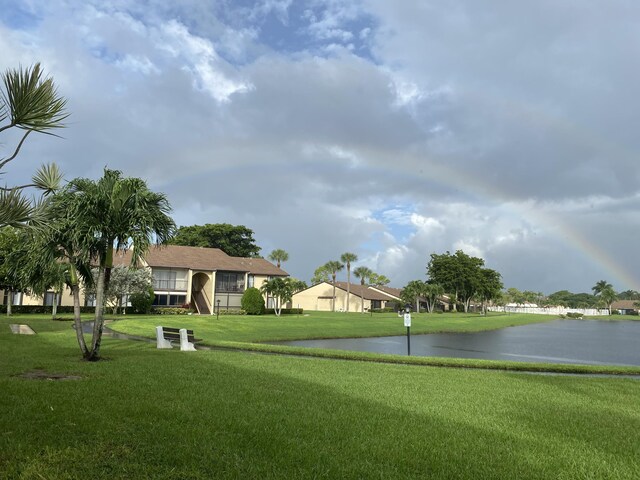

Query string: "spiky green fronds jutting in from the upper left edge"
[[0, 63, 68, 227]]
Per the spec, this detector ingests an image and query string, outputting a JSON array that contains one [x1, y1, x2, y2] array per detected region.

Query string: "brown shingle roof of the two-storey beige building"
[[114, 245, 289, 277]]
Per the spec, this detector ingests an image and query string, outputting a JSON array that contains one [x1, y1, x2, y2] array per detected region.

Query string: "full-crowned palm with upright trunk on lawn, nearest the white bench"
[[67, 168, 175, 360]]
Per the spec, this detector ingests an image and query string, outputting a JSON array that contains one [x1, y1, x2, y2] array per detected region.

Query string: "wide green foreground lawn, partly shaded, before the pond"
[[0, 316, 640, 479]]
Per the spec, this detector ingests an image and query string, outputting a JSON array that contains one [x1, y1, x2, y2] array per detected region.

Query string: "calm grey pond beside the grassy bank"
[[269, 320, 640, 366]]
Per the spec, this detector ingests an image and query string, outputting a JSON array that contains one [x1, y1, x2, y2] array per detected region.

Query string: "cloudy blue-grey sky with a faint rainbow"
[[0, 0, 640, 294]]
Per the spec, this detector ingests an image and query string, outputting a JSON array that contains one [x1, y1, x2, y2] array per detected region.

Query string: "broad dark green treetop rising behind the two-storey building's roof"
[[169, 223, 262, 258]]
